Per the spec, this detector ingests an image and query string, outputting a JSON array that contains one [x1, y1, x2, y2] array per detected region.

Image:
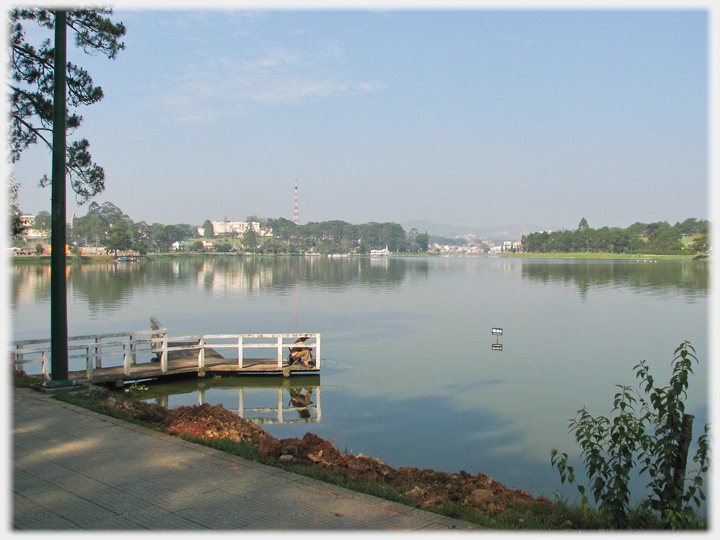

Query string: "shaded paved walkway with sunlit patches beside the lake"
[[12, 389, 479, 532]]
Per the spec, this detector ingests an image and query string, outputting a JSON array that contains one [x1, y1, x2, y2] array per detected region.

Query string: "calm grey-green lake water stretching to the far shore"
[[10, 257, 710, 499]]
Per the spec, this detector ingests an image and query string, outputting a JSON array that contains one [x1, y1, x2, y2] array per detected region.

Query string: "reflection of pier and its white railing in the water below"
[[142, 375, 322, 424]]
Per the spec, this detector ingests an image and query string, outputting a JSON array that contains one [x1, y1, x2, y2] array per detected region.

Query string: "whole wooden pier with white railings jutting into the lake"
[[10, 318, 320, 385]]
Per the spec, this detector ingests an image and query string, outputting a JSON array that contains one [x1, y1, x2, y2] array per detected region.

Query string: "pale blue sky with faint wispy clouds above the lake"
[[11, 0, 714, 229]]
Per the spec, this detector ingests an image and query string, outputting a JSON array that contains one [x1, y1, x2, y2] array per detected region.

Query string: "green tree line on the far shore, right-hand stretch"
[[522, 218, 710, 255]]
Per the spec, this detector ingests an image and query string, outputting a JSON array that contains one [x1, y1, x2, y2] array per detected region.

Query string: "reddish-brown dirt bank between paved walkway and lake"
[[104, 398, 551, 513]]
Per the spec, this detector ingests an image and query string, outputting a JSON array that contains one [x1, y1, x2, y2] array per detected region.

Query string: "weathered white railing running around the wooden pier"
[[10, 317, 320, 381]]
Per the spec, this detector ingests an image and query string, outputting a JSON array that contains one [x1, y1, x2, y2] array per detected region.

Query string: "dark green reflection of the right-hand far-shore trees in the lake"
[[522, 261, 710, 298]]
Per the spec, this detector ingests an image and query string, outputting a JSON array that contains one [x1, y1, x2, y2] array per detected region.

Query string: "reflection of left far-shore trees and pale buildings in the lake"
[[11, 257, 428, 310]]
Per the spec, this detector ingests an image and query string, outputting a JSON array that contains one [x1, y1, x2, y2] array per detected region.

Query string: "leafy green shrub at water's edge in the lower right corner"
[[551, 341, 710, 529]]
